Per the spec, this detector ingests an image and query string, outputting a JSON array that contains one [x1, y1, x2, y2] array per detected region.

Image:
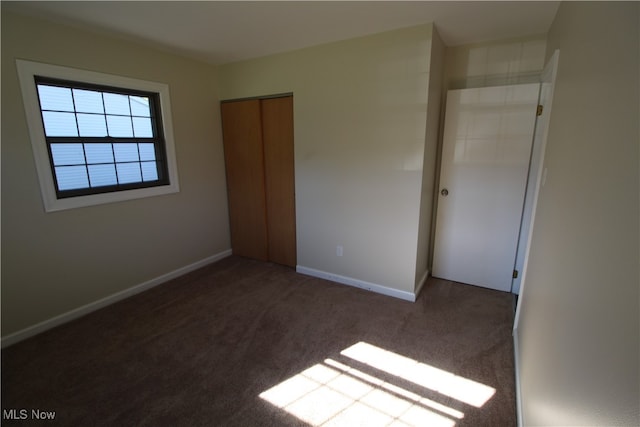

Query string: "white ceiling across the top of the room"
[[2, 1, 560, 64]]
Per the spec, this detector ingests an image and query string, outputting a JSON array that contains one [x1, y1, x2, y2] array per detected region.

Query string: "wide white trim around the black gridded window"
[[16, 59, 180, 212]]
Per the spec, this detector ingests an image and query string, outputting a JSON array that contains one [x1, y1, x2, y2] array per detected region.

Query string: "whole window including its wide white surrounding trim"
[[18, 60, 178, 211]]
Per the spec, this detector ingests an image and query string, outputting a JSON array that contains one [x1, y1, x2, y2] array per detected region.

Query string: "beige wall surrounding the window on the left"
[[2, 10, 230, 337]]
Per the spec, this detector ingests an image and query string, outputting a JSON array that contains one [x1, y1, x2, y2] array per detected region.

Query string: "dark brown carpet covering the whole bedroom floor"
[[2, 256, 516, 427]]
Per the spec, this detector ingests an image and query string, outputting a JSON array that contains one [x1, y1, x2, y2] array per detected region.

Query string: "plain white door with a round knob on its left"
[[433, 83, 540, 291]]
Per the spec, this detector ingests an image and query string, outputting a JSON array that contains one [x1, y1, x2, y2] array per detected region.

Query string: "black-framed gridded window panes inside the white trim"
[[35, 76, 167, 198]]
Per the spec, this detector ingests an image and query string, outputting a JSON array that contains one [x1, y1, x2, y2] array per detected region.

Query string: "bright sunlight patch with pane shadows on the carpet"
[[260, 342, 495, 427]]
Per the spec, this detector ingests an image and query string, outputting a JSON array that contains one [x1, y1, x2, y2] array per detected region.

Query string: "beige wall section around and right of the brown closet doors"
[[220, 24, 433, 293]]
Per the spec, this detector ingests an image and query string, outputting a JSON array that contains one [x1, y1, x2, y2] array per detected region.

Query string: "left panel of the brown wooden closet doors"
[[220, 99, 269, 261]]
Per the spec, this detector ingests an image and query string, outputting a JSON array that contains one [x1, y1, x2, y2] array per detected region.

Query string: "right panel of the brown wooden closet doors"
[[261, 96, 296, 267]]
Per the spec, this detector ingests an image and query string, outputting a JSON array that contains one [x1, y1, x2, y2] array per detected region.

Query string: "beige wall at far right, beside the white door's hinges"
[[516, 2, 640, 426]]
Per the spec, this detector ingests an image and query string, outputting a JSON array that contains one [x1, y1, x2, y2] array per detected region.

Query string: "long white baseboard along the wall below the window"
[[1, 249, 231, 348]]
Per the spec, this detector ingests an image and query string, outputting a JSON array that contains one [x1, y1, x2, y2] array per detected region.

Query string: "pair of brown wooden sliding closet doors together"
[[220, 94, 296, 267]]
